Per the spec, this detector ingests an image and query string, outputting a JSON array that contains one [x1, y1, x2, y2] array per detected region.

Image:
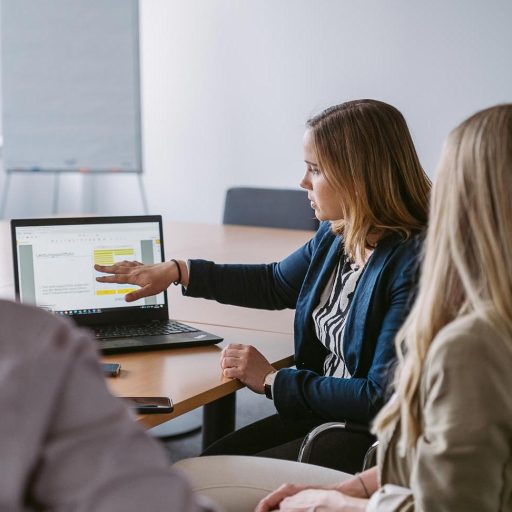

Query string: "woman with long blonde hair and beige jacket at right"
[[258, 104, 512, 512]]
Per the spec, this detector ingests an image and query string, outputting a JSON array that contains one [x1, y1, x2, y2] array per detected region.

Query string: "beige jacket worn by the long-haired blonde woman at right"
[[368, 316, 512, 512]]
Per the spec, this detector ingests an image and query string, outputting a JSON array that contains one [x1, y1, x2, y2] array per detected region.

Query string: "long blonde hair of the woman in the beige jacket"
[[375, 104, 512, 447]]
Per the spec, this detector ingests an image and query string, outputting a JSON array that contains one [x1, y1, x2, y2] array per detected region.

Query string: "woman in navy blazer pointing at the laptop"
[[96, 100, 430, 471]]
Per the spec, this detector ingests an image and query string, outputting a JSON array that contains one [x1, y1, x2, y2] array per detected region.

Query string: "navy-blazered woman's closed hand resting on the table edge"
[[220, 343, 275, 394]]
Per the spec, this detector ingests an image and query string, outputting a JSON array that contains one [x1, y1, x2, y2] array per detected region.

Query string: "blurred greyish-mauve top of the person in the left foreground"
[[0, 301, 216, 512]]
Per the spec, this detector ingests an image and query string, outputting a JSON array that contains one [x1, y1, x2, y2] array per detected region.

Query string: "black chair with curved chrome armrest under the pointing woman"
[[297, 421, 378, 474]]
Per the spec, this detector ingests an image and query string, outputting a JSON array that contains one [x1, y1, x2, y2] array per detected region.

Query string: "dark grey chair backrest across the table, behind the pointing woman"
[[223, 187, 318, 231]]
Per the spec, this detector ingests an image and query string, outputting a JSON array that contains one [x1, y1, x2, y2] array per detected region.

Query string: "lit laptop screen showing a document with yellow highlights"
[[13, 216, 167, 316]]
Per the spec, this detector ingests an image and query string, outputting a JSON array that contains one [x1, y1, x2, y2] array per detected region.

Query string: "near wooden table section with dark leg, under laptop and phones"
[[103, 323, 293, 447]]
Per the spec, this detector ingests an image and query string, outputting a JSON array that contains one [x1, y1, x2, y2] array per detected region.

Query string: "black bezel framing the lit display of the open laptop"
[[11, 215, 169, 326]]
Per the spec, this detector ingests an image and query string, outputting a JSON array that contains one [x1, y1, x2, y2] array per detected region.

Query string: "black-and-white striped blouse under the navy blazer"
[[313, 257, 363, 378]]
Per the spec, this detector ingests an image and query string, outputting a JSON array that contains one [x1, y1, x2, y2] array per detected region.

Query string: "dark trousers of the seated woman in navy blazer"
[[202, 414, 375, 473]]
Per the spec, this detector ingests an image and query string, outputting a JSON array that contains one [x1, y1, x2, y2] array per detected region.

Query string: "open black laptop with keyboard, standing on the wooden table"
[[11, 215, 222, 354]]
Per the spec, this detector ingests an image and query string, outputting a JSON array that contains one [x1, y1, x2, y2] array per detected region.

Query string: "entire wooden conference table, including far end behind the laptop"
[[0, 222, 312, 444]]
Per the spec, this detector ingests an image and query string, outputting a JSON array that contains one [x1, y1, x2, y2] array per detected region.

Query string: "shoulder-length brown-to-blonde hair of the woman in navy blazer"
[[306, 100, 431, 258]]
